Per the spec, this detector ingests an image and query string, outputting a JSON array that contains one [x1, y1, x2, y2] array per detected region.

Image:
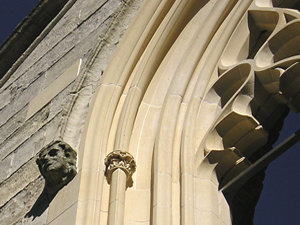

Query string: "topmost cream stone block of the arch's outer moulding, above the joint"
[[103, 0, 173, 85]]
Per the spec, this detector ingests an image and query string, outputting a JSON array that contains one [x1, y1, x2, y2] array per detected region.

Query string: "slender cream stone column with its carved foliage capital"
[[105, 150, 136, 225]]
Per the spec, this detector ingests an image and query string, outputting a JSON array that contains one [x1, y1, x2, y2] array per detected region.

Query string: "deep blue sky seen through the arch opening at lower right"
[[254, 112, 300, 225]]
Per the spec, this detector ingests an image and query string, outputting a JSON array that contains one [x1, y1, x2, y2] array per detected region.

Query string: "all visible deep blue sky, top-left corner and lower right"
[[0, 0, 300, 225]]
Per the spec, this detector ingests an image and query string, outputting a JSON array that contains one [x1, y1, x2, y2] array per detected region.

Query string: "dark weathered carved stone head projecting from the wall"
[[36, 140, 77, 194]]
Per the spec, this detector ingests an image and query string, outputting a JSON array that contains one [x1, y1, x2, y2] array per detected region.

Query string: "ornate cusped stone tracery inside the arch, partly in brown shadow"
[[205, 1, 300, 183]]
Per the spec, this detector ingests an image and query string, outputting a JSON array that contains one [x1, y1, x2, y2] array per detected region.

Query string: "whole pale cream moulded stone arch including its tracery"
[[45, 0, 300, 225]]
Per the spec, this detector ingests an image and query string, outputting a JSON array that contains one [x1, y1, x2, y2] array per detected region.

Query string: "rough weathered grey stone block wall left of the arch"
[[0, 0, 143, 225]]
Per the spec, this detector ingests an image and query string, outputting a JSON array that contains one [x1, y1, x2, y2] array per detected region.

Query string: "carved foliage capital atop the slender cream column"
[[105, 150, 136, 187]]
